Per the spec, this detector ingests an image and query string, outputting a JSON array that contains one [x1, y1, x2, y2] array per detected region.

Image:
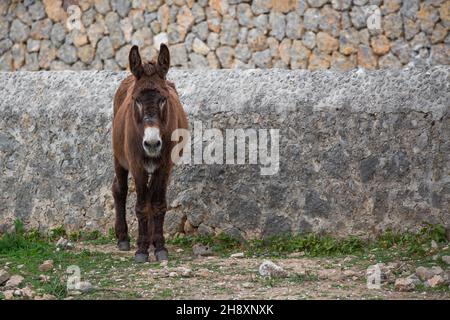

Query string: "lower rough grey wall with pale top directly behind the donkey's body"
[[0, 66, 450, 237]]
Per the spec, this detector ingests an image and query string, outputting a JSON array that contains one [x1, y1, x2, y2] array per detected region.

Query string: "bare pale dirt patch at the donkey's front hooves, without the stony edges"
[[69, 244, 450, 299]]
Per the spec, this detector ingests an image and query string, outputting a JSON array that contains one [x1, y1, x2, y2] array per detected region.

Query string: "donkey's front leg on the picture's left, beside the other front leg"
[[134, 174, 153, 262]]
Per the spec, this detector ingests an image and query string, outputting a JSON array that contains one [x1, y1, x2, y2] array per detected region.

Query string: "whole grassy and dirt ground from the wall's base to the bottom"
[[0, 225, 450, 299]]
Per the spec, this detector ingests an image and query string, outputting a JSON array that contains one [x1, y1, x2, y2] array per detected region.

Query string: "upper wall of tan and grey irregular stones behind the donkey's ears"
[[0, 0, 450, 71]]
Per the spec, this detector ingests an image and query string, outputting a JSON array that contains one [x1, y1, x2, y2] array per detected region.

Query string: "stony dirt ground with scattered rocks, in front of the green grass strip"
[[0, 240, 450, 300]]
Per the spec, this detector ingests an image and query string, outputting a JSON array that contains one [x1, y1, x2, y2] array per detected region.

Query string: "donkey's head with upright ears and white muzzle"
[[129, 44, 170, 158]]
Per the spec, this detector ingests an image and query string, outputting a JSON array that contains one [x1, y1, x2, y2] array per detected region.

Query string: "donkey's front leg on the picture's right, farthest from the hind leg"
[[150, 168, 170, 261]]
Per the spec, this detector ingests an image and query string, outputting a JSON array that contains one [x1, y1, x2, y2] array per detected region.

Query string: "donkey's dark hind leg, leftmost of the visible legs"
[[112, 159, 130, 251]]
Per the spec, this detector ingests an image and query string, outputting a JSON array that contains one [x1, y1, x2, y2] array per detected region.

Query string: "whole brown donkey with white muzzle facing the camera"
[[112, 44, 188, 262]]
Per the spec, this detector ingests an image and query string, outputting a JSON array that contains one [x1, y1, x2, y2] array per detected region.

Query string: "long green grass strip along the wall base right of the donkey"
[[168, 224, 447, 261]]
